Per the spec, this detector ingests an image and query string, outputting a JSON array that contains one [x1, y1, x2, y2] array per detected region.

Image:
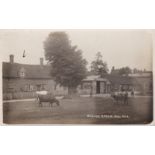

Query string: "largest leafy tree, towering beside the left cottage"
[[44, 32, 87, 94]]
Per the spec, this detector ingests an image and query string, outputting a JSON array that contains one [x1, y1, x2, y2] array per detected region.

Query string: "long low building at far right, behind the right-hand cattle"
[[109, 67, 153, 94]]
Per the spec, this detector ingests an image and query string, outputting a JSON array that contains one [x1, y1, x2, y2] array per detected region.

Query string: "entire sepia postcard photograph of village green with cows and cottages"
[[0, 29, 153, 125]]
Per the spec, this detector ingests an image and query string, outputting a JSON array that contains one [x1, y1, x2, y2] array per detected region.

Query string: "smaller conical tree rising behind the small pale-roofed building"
[[91, 52, 108, 75]]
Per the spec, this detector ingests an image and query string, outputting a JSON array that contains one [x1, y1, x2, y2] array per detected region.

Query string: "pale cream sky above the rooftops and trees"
[[0, 29, 152, 70]]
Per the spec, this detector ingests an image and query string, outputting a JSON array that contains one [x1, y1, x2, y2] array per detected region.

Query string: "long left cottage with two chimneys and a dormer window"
[[3, 55, 68, 98]]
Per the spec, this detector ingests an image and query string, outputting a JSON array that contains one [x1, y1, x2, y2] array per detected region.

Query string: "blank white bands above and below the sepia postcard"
[[0, 0, 155, 155]]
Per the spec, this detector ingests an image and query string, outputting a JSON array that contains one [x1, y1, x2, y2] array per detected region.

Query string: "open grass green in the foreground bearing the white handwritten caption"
[[3, 97, 153, 124]]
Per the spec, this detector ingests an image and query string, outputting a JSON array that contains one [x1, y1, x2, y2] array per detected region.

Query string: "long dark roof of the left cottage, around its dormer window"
[[3, 62, 52, 79]]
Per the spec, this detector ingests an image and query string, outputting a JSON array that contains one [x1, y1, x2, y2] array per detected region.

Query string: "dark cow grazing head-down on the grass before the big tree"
[[37, 94, 60, 107]]
